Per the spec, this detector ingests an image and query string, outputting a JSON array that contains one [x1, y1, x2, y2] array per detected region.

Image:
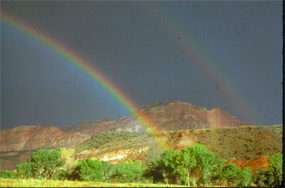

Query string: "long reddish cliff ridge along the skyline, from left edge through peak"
[[0, 101, 243, 151]]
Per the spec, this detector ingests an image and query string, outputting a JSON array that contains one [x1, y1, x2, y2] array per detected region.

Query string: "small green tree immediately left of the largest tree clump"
[[114, 160, 143, 182]]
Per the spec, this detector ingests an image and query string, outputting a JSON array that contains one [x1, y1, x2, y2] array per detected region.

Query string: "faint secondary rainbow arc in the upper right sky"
[[141, 2, 262, 125]]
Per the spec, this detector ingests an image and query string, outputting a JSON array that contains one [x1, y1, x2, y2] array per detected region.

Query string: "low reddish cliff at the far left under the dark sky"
[[0, 125, 90, 151]]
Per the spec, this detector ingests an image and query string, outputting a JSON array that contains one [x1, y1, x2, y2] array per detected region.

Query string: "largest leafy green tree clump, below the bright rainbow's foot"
[[144, 144, 223, 186]]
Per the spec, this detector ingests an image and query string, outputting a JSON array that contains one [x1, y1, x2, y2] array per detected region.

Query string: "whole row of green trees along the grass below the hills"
[[0, 144, 283, 187]]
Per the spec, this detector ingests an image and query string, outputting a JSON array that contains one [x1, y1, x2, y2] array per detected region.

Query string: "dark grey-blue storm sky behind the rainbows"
[[1, 1, 283, 128]]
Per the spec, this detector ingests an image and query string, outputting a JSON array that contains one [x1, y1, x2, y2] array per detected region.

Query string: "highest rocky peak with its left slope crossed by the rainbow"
[[62, 100, 246, 132]]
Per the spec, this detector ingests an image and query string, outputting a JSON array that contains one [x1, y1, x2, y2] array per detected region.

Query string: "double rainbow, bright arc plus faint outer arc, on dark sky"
[[1, 6, 257, 148]]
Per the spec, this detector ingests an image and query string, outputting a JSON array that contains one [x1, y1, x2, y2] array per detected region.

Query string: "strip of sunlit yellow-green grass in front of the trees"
[[0, 178, 184, 187]]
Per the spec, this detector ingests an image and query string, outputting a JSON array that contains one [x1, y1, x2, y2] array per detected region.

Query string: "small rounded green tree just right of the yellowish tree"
[[73, 158, 103, 181]]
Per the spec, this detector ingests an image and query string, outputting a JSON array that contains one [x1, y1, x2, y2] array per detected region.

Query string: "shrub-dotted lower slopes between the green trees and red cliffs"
[[0, 125, 283, 169]]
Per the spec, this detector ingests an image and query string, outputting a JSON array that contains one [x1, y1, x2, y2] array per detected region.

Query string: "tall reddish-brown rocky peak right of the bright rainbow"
[[135, 101, 245, 130]]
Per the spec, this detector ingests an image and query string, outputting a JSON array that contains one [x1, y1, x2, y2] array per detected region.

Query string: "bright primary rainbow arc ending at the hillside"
[[1, 12, 167, 149]]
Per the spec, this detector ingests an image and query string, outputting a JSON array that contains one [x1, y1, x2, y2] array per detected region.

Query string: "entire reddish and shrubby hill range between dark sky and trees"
[[0, 101, 283, 169]]
